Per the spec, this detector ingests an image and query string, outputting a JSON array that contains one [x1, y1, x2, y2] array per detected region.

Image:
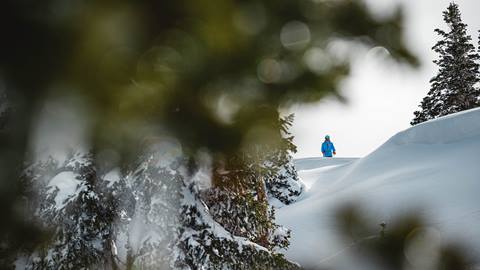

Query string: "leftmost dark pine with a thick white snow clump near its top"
[[23, 153, 122, 269]]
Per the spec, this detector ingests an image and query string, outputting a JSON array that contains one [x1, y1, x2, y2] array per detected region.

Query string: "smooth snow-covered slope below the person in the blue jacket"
[[277, 109, 480, 269]]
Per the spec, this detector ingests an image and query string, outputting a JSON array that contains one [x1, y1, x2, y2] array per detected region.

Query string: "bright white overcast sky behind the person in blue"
[[292, 0, 480, 158]]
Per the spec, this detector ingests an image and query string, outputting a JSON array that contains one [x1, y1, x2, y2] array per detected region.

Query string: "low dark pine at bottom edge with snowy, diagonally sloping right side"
[[175, 180, 301, 270]]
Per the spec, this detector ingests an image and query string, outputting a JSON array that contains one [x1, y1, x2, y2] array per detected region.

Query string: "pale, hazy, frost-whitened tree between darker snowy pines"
[[121, 151, 185, 270]]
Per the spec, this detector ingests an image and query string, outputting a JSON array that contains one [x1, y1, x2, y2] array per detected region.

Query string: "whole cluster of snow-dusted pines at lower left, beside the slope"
[[18, 116, 302, 269]]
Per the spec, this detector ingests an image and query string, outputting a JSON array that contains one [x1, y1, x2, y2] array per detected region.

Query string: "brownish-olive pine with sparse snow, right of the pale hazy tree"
[[201, 153, 275, 249]]
